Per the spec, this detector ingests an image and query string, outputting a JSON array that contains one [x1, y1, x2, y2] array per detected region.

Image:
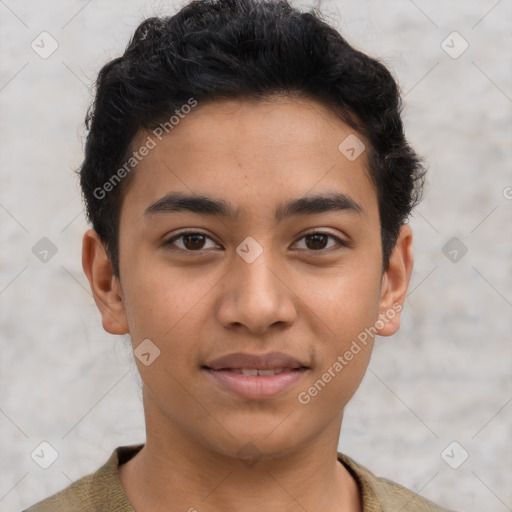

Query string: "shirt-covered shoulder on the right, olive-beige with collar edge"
[[338, 453, 453, 512]]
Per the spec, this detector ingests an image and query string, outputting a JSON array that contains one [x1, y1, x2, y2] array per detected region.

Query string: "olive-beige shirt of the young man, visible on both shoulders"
[[24, 444, 456, 512]]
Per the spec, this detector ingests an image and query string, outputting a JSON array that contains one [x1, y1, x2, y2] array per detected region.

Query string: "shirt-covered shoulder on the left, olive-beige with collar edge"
[[23, 445, 142, 512]]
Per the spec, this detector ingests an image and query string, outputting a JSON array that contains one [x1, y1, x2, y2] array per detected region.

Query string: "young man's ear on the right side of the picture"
[[376, 225, 414, 336]]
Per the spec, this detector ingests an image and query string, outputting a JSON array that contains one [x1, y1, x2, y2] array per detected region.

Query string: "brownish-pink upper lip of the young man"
[[204, 352, 307, 370]]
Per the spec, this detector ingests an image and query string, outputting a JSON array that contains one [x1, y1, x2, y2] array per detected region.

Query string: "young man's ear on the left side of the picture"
[[82, 229, 129, 334]]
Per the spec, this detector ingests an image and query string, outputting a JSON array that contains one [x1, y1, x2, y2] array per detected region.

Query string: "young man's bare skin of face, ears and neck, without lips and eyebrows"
[[83, 97, 413, 512]]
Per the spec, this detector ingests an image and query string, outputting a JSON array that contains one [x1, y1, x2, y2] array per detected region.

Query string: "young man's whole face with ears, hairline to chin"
[[84, 98, 412, 456]]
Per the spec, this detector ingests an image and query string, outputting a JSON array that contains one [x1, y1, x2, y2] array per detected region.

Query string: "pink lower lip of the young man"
[[204, 368, 306, 400]]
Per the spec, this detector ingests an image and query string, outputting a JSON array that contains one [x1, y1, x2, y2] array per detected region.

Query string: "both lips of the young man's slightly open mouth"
[[202, 352, 309, 400]]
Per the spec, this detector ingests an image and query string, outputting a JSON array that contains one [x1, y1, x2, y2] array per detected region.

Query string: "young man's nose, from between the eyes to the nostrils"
[[217, 250, 297, 335]]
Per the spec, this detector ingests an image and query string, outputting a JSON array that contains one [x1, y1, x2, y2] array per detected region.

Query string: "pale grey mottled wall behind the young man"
[[0, 0, 512, 512]]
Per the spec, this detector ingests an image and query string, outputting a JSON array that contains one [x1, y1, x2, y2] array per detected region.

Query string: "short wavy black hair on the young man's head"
[[79, 0, 425, 277]]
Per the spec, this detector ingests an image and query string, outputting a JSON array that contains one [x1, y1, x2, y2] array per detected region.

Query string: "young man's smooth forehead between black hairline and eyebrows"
[[119, 97, 376, 223]]
